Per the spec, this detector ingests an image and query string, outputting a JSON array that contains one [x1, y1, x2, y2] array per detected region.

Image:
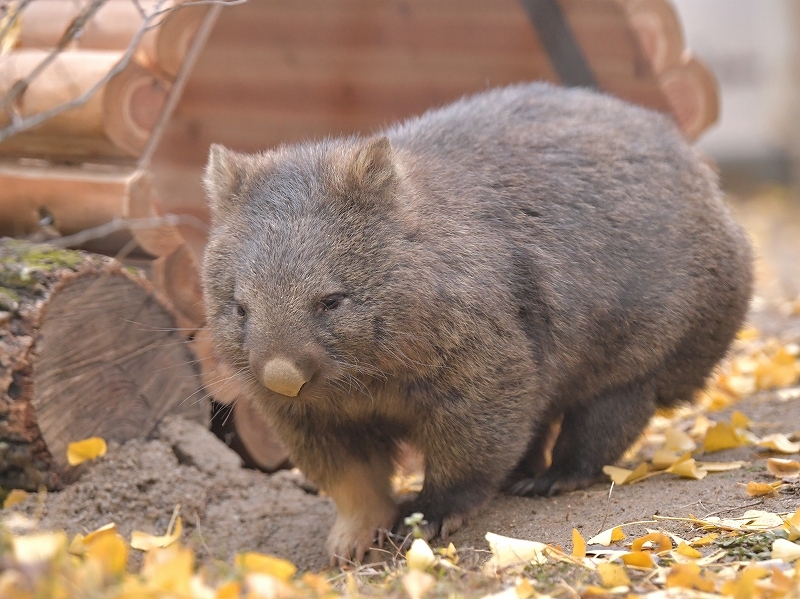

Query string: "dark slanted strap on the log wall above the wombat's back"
[[522, 0, 597, 88]]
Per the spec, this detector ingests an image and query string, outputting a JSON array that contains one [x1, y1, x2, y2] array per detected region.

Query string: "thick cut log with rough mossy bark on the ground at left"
[[0, 239, 208, 490]]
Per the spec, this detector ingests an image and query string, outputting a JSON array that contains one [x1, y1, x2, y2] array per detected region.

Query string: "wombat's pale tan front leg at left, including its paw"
[[323, 457, 397, 566]]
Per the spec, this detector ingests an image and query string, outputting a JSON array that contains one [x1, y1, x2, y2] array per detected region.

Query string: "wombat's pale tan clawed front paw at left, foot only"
[[326, 509, 397, 566]]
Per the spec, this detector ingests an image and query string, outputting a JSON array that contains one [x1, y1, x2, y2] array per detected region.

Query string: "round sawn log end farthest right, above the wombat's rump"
[[659, 50, 719, 139]]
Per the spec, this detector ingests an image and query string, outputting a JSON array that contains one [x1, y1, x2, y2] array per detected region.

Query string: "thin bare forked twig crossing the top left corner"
[[0, 0, 246, 142]]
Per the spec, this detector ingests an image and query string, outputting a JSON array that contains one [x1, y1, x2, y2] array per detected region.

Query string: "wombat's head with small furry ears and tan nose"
[[203, 137, 402, 399]]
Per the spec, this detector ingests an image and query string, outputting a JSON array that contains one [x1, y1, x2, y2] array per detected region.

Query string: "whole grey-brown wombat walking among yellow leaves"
[[204, 84, 751, 559]]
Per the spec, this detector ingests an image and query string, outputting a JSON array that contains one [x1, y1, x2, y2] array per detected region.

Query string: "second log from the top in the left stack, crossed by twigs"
[[0, 50, 169, 158]]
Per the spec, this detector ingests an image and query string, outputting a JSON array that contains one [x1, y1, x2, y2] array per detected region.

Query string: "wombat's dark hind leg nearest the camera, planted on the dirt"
[[507, 381, 656, 495]]
